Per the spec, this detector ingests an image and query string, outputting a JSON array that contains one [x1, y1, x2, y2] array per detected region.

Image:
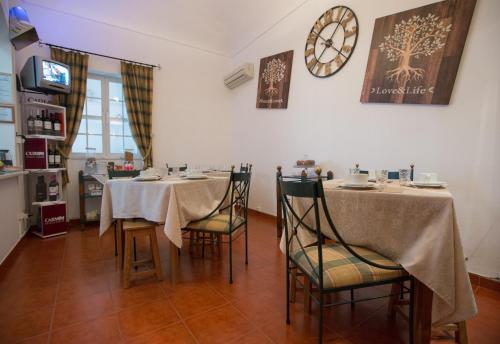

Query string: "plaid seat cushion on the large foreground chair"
[[291, 244, 406, 289]]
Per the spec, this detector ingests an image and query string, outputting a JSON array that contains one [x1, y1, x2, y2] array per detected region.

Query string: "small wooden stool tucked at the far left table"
[[123, 220, 163, 288]]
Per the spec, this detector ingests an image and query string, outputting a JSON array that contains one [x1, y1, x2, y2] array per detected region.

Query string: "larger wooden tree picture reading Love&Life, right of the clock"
[[360, 0, 477, 105]]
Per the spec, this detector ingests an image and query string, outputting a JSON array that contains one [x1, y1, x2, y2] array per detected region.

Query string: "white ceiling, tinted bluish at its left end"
[[25, 0, 308, 56]]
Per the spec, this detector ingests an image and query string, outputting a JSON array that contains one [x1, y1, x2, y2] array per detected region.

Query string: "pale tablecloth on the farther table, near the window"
[[99, 176, 229, 247]]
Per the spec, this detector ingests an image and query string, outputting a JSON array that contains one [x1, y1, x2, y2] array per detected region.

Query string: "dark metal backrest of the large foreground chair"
[[278, 176, 403, 286]]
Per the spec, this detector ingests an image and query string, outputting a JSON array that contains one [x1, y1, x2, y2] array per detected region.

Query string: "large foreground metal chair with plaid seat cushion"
[[278, 171, 414, 343]]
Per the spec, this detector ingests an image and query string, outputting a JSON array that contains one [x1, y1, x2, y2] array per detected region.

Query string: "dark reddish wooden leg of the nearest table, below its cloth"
[[413, 279, 433, 344]]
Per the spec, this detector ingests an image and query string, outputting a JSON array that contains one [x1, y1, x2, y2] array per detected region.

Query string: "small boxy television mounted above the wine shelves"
[[21, 56, 71, 93]]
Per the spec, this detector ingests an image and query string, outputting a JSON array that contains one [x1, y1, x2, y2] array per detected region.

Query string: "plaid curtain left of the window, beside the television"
[[50, 48, 89, 185]]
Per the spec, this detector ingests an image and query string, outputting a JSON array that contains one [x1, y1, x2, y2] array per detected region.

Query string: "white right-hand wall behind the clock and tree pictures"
[[232, 0, 500, 276]]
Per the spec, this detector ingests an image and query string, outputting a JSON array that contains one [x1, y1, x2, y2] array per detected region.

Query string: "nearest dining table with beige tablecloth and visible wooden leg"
[[280, 179, 477, 343]]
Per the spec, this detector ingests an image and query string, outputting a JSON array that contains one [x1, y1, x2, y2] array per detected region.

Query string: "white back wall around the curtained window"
[[13, 3, 230, 219]]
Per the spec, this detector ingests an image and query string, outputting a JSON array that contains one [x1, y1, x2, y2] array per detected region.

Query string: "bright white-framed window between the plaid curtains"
[[72, 74, 139, 158]]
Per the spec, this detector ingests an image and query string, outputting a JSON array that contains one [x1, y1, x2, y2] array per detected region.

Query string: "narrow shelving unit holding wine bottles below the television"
[[22, 101, 67, 238]]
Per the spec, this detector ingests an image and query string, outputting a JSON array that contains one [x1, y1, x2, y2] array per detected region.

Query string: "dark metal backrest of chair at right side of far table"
[[193, 165, 252, 227]]
